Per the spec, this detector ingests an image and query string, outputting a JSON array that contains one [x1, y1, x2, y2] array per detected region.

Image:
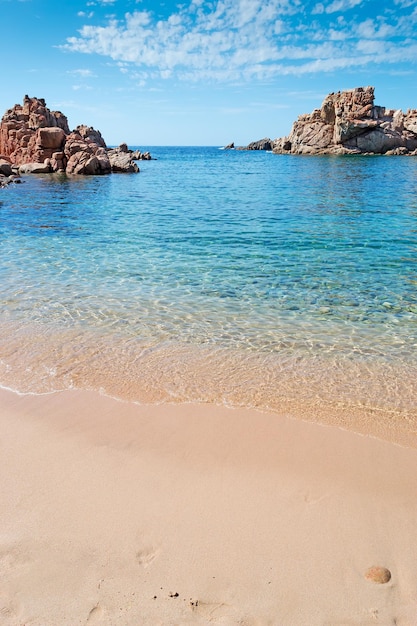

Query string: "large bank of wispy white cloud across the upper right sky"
[[63, 0, 417, 81]]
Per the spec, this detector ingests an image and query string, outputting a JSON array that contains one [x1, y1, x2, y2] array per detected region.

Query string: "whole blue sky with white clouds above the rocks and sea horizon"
[[0, 0, 417, 146]]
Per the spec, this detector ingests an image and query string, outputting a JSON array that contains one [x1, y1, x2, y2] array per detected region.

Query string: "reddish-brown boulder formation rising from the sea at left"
[[0, 96, 142, 175]]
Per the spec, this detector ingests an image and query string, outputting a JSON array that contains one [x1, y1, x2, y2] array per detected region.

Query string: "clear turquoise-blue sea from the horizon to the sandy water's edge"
[[0, 146, 417, 433]]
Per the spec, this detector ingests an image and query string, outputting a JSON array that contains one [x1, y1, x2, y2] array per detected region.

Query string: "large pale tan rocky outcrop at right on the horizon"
[[273, 87, 417, 154]]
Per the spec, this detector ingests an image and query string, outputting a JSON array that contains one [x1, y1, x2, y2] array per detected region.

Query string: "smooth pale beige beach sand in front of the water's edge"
[[0, 391, 417, 626]]
